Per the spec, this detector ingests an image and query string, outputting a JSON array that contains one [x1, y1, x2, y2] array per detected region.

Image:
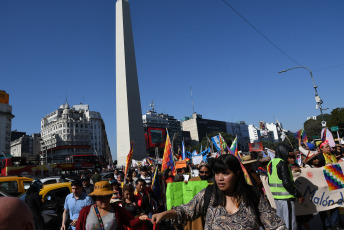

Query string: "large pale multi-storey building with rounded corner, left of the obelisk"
[[41, 102, 111, 163]]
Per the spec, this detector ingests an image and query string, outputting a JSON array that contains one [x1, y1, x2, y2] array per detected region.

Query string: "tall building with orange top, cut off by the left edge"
[[0, 90, 14, 155]]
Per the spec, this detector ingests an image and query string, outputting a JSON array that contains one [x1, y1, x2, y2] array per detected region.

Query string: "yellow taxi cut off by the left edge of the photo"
[[0, 176, 33, 196]]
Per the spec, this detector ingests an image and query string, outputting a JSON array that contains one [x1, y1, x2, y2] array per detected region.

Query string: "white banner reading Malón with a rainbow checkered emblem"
[[261, 162, 344, 216]]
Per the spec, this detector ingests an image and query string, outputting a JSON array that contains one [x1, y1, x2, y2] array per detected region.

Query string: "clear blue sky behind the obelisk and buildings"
[[0, 0, 344, 160]]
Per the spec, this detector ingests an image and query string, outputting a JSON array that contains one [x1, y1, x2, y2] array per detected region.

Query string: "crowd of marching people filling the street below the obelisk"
[[4, 141, 344, 230]]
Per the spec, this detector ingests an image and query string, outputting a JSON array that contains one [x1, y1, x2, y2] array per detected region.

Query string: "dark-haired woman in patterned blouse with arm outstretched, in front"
[[152, 154, 287, 230]]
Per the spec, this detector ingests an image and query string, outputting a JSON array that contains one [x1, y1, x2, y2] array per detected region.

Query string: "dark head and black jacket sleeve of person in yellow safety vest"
[[275, 144, 302, 198]]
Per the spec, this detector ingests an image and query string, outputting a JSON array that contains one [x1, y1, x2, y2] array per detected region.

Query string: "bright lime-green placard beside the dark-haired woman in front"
[[166, 180, 208, 210]]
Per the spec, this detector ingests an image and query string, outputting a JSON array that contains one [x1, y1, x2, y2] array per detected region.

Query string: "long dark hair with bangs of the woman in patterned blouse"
[[213, 154, 260, 216]]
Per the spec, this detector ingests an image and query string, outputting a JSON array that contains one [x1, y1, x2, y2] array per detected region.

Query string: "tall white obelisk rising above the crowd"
[[116, 0, 147, 165]]
